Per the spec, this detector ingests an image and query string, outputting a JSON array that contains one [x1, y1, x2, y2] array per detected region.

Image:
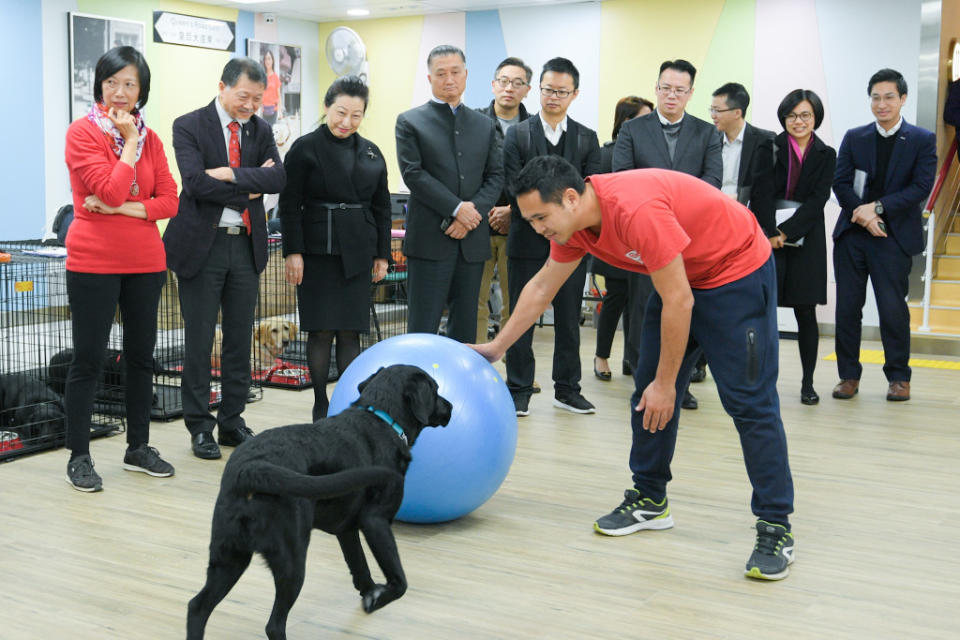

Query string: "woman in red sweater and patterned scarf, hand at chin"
[[64, 47, 177, 491]]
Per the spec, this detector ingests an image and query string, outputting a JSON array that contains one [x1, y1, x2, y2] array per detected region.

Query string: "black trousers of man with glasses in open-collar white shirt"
[[507, 258, 587, 396]]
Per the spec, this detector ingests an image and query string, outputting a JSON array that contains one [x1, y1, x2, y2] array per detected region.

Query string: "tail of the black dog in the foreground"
[[237, 461, 403, 500]]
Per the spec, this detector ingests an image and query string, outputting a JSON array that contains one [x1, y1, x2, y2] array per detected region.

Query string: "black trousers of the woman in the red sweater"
[[64, 271, 167, 455]]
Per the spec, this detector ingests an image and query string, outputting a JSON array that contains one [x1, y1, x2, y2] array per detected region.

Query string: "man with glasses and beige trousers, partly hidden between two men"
[[477, 58, 533, 343]]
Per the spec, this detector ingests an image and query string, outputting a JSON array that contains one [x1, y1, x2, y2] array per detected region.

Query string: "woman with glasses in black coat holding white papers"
[[751, 89, 837, 404]]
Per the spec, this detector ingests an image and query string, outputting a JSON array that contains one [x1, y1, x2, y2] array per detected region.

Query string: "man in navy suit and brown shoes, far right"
[[833, 69, 937, 401]]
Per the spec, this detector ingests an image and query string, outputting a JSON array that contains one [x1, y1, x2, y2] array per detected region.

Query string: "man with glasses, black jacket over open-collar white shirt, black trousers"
[[503, 58, 600, 416]]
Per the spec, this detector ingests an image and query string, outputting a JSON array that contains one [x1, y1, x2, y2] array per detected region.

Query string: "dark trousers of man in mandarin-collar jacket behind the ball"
[[407, 251, 484, 343]]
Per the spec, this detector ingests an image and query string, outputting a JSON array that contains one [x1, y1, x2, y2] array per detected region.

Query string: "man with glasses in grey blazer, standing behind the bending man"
[[613, 60, 723, 409]]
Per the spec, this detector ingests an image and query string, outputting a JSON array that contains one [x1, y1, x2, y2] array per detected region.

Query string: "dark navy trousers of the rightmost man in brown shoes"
[[833, 227, 913, 382]]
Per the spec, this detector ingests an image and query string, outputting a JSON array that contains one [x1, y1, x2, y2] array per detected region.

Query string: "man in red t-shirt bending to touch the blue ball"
[[474, 156, 794, 580]]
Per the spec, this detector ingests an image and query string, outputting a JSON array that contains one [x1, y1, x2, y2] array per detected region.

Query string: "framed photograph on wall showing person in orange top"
[[247, 40, 302, 155]]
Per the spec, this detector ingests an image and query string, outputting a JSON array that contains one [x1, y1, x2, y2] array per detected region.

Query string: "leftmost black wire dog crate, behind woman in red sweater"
[[0, 242, 125, 460]]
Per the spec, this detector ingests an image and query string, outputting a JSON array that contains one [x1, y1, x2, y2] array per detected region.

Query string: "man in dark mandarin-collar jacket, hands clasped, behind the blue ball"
[[396, 45, 503, 342]]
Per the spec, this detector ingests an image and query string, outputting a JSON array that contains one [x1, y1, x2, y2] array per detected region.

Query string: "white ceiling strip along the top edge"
[[202, 0, 599, 22]]
